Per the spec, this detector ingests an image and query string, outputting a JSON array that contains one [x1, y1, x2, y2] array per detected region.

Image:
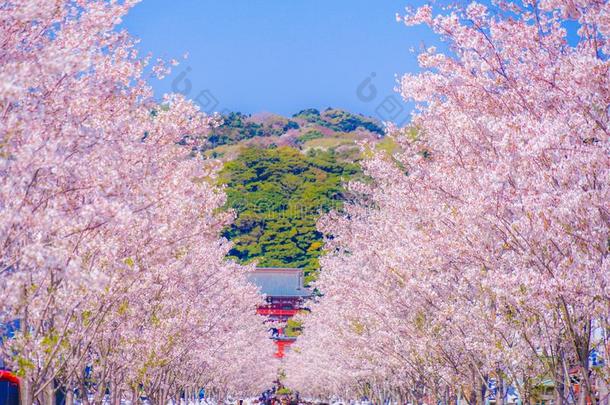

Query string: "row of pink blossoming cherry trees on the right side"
[[286, 0, 610, 404]]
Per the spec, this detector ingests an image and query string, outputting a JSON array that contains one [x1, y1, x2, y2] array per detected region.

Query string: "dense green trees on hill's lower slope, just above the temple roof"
[[220, 147, 359, 280]]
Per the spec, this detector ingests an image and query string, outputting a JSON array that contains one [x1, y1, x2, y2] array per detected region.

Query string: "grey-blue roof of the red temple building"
[[248, 267, 311, 297]]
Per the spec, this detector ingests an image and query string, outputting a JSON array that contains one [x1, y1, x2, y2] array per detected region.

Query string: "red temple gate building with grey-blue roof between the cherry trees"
[[249, 267, 311, 358]]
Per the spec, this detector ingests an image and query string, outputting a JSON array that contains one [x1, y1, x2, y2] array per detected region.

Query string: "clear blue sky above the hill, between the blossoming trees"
[[123, 0, 438, 121]]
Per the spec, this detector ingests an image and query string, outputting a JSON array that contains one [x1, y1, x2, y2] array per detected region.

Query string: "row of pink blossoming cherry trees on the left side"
[[0, 0, 274, 404]]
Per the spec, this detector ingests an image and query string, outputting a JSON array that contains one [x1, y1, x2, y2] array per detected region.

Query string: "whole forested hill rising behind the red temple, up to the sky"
[[203, 108, 392, 281]]
